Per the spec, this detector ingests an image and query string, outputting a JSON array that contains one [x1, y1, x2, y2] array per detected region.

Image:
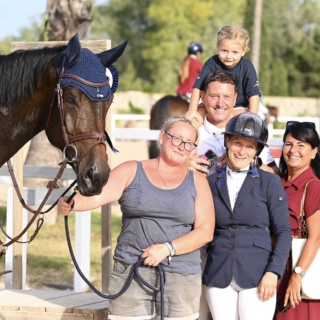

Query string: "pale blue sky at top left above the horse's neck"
[[0, 0, 107, 40]]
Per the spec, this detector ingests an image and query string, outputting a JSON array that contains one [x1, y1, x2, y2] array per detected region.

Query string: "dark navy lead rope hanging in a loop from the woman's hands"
[[64, 192, 166, 320]]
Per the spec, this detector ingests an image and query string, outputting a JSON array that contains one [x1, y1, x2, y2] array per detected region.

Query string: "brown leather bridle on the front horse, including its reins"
[[0, 57, 116, 252]]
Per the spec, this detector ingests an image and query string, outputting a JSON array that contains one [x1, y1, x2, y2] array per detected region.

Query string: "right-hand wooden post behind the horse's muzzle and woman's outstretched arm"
[[101, 40, 112, 293]]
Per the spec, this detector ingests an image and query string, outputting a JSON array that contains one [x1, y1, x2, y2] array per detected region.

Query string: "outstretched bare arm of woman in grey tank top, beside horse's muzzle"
[[58, 161, 137, 215]]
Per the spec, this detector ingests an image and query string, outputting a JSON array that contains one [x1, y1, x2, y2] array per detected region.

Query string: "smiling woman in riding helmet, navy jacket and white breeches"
[[203, 112, 291, 320]]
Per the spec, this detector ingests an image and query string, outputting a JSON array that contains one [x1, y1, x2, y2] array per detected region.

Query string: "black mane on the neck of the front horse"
[[0, 46, 66, 106]]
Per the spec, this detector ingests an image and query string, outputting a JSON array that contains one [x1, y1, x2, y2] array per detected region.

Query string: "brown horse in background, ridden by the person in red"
[[149, 95, 189, 159]]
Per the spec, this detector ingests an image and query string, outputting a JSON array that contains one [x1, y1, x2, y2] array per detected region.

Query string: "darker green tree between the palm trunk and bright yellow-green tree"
[[91, 0, 152, 91]]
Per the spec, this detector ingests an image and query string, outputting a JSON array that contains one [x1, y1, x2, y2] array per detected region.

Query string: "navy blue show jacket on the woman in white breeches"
[[202, 168, 292, 289]]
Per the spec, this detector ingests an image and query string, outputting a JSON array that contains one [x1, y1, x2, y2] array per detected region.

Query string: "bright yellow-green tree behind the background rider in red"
[[142, 0, 213, 93]]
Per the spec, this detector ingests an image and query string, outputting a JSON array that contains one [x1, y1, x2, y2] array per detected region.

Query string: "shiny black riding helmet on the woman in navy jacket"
[[223, 112, 268, 156]]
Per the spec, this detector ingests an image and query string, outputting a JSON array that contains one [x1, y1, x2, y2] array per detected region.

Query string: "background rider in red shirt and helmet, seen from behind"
[[177, 41, 203, 99]]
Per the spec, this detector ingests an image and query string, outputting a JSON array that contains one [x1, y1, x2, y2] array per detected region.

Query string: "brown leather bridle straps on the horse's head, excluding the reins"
[[46, 60, 115, 171]]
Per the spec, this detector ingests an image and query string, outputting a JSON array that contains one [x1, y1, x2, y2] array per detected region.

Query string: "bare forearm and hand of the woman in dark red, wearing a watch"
[[284, 210, 320, 307]]
